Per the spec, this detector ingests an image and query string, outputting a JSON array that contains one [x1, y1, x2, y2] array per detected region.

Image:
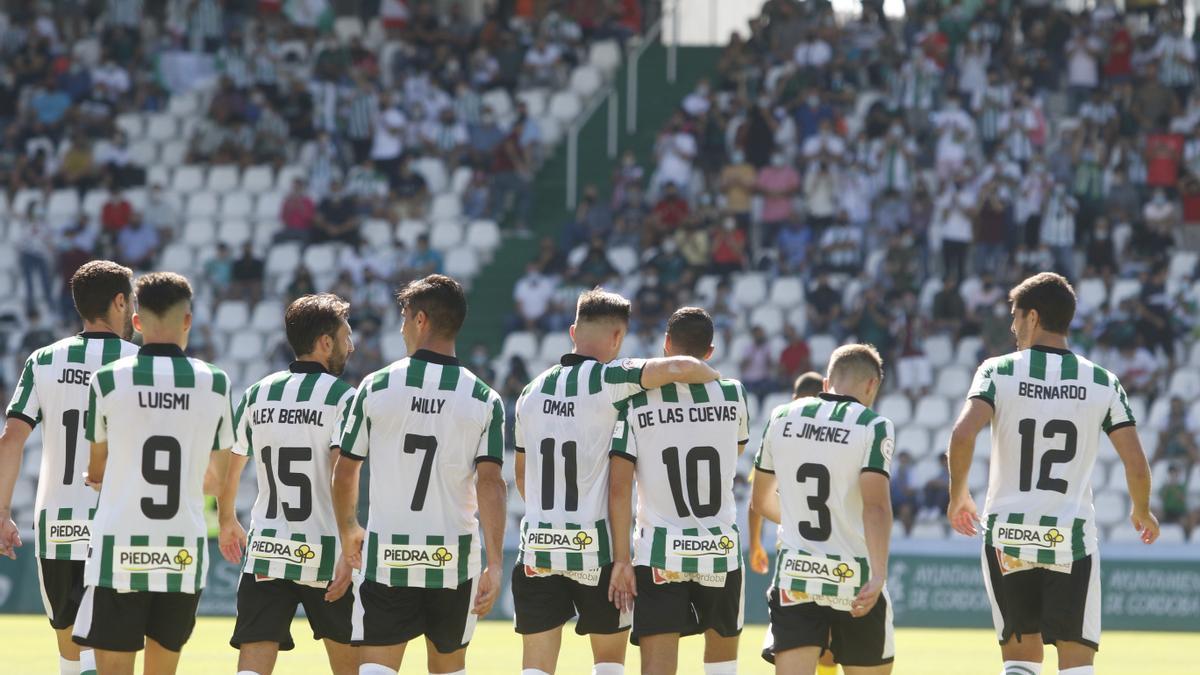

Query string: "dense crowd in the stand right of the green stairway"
[[510, 0, 1200, 532]]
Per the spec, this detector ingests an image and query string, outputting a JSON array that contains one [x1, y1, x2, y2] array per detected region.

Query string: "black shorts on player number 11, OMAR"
[[512, 561, 634, 635]]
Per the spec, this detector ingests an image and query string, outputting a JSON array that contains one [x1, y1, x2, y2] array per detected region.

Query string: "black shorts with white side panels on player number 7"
[[350, 577, 479, 653]]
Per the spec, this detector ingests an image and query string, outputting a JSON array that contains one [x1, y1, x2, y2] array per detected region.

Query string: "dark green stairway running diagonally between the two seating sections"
[[460, 42, 721, 345]]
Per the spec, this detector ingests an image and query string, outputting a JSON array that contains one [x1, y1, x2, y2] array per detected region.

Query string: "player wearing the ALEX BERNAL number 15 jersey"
[[218, 293, 359, 675]]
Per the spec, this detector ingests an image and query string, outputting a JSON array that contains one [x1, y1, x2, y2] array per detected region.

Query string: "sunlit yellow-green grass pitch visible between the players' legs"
[[0, 615, 1200, 675]]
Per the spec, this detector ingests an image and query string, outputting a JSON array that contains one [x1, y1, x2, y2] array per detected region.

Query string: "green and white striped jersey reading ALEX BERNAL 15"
[[233, 362, 354, 584]]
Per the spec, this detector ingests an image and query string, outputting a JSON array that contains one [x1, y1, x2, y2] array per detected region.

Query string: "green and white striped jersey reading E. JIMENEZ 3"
[[755, 393, 895, 595]]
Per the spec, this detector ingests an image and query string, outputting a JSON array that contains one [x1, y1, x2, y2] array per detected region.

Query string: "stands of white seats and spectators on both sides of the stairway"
[[0, 0, 1200, 547]]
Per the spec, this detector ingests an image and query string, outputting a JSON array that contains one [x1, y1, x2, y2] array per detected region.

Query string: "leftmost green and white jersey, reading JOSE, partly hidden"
[[7, 333, 138, 560]]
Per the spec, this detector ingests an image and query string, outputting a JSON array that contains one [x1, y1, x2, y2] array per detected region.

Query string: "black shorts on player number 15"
[[229, 574, 354, 651]]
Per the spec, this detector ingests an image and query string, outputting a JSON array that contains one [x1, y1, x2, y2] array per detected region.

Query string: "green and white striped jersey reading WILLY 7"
[[341, 350, 504, 589]]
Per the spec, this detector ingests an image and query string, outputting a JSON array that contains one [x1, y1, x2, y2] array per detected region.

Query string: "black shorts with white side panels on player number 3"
[[762, 589, 895, 668]]
